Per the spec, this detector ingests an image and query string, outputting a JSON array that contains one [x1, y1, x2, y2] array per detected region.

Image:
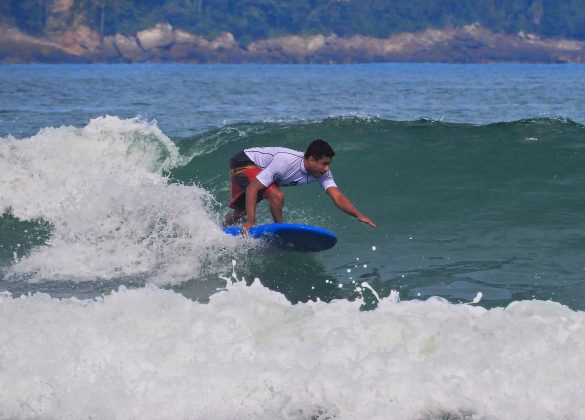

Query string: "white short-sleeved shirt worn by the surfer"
[[244, 147, 337, 190]]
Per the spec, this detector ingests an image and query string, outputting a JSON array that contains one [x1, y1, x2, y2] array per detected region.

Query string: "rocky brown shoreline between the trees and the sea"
[[0, 24, 585, 64]]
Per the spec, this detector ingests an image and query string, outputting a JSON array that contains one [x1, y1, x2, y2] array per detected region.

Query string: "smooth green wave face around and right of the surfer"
[[171, 118, 585, 307]]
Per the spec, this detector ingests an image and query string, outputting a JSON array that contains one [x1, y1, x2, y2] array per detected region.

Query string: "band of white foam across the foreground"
[[0, 282, 585, 419]]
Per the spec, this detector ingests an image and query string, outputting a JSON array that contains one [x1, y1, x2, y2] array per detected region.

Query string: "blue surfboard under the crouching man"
[[223, 223, 337, 252]]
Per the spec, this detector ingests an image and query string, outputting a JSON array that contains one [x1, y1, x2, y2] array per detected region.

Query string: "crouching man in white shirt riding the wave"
[[224, 139, 376, 231]]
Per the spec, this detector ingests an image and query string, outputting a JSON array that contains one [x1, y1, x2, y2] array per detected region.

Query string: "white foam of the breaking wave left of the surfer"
[[0, 116, 233, 284]]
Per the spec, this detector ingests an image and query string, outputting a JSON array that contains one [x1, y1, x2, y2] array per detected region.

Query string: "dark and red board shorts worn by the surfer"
[[228, 151, 276, 211]]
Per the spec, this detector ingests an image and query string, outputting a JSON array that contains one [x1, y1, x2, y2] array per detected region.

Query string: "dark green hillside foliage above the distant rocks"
[[0, 0, 585, 43]]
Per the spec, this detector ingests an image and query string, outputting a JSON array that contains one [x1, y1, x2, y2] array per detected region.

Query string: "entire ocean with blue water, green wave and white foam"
[[0, 64, 585, 419]]
